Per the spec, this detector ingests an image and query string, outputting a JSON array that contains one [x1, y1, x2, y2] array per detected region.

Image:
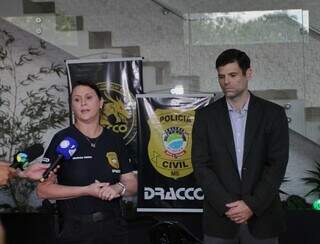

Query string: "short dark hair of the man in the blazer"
[[216, 49, 250, 74]]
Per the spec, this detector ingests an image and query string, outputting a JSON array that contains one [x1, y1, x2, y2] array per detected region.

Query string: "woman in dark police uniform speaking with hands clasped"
[[37, 82, 137, 244]]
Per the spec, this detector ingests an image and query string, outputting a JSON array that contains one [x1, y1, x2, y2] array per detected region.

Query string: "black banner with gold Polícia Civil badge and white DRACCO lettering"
[[137, 95, 213, 212]]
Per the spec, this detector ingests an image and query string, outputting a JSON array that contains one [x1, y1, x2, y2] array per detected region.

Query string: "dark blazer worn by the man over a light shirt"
[[192, 94, 289, 239]]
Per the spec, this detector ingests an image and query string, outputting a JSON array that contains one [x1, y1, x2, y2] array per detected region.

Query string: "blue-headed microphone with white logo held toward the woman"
[[40, 136, 78, 182]]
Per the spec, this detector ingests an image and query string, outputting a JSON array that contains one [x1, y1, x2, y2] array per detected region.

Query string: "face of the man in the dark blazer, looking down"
[[217, 62, 252, 99]]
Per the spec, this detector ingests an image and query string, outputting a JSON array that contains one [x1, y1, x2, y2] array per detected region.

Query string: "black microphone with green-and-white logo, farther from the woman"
[[10, 143, 44, 170]]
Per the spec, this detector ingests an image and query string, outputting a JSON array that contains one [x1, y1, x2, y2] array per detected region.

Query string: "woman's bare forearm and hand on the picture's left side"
[[37, 173, 108, 200]]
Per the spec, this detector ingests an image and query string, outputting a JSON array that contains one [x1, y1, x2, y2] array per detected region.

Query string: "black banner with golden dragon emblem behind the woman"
[[66, 58, 142, 166]]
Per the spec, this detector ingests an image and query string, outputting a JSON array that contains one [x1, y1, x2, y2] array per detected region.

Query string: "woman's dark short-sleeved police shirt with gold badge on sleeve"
[[43, 126, 133, 214]]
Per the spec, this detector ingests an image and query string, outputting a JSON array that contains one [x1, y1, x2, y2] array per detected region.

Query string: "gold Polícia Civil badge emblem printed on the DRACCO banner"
[[148, 109, 194, 179]]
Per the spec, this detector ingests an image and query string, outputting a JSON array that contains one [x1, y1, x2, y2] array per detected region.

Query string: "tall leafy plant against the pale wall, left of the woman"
[[0, 29, 68, 212]]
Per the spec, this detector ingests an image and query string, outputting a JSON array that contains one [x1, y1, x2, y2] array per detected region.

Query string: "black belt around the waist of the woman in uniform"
[[63, 211, 120, 222]]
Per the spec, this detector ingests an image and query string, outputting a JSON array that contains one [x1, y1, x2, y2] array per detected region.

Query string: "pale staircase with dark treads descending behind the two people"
[[4, 0, 320, 144]]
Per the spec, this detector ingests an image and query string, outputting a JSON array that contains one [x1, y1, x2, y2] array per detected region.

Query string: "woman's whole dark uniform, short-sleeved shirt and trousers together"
[[43, 126, 133, 244]]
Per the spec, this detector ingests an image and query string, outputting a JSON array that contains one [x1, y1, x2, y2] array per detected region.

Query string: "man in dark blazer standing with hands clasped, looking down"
[[192, 49, 289, 244]]
